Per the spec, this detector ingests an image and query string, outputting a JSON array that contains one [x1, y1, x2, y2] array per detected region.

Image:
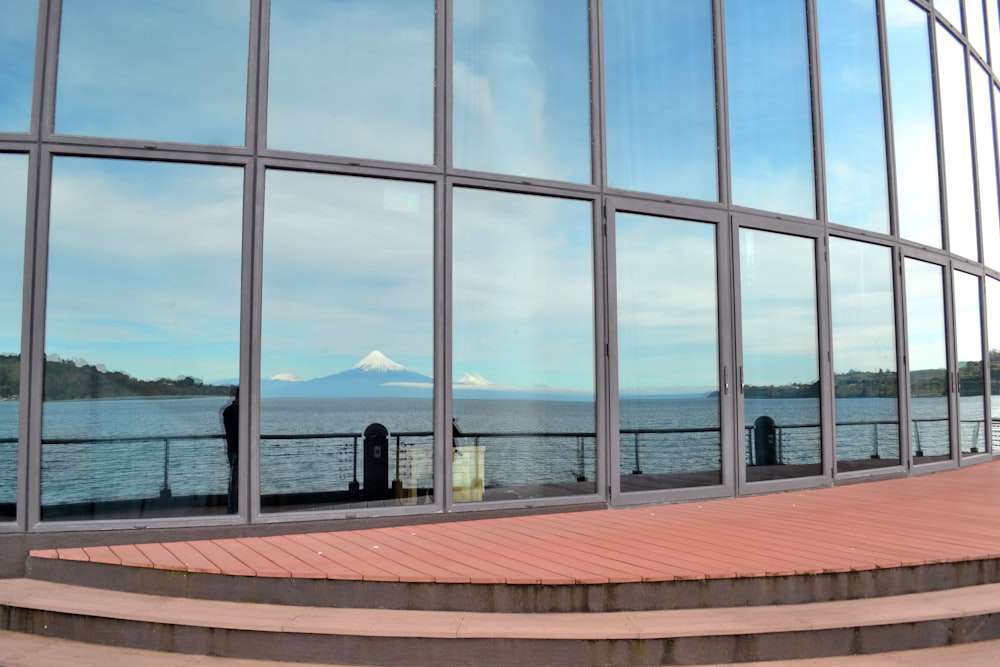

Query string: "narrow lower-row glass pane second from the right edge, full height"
[[953, 271, 986, 454]]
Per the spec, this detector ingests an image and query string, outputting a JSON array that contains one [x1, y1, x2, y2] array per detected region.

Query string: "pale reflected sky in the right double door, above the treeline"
[[739, 229, 819, 386]]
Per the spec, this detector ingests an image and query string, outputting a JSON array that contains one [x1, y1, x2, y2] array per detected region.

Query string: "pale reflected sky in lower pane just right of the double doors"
[[830, 237, 896, 373]]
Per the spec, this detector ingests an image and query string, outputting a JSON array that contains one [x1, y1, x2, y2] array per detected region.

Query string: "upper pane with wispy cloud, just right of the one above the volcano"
[[452, 0, 591, 183]]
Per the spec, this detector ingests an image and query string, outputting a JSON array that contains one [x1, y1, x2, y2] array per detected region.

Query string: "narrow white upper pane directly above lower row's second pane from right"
[[937, 24, 979, 259]]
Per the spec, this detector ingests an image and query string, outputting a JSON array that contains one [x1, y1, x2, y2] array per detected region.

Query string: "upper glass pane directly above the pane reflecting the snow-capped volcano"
[[267, 0, 434, 164]]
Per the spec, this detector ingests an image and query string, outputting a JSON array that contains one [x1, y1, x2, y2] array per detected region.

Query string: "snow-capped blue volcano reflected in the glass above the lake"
[[260, 350, 434, 398]]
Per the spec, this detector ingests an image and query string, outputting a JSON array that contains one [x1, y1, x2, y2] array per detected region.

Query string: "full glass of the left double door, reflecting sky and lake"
[[615, 214, 722, 491]]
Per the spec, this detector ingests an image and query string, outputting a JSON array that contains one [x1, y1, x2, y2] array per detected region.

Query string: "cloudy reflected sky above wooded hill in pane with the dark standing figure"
[[45, 157, 243, 382]]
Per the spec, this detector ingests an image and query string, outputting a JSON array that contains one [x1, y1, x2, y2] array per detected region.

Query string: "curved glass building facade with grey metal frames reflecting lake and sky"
[[0, 0, 1000, 533]]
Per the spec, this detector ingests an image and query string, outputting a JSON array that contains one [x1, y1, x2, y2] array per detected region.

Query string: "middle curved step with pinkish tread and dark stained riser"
[[0, 579, 1000, 667]]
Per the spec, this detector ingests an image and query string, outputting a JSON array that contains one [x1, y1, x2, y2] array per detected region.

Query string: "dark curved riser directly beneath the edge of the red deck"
[[27, 555, 1000, 613]]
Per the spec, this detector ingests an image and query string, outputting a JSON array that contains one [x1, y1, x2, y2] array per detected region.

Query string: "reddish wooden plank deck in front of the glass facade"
[[27, 461, 1000, 584]]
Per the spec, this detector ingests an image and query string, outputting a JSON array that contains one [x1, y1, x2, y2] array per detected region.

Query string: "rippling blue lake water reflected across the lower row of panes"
[[0, 397, 996, 505]]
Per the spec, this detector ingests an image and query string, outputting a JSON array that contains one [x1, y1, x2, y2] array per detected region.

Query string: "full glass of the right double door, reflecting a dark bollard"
[[739, 229, 822, 482]]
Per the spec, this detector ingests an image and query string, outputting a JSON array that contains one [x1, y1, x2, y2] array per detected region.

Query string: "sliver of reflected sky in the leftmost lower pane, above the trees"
[[0, 153, 28, 354]]
